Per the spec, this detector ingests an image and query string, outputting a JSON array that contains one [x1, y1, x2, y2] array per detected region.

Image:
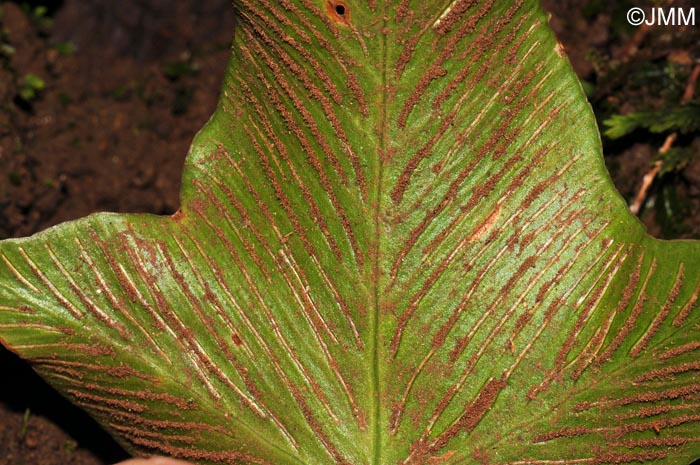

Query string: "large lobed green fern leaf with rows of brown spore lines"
[[0, 0, 700, 465]]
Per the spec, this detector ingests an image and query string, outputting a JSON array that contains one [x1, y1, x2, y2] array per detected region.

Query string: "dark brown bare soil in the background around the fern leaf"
[[0, 0, 700, 465]]
